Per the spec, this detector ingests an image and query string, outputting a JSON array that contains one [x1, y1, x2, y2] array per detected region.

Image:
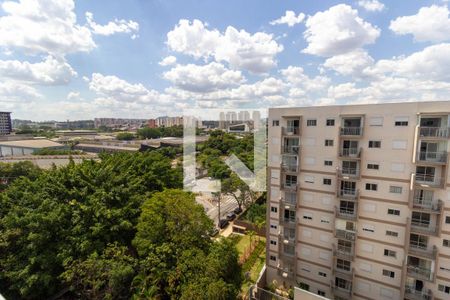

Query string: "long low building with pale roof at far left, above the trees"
[[0, 139, 67, 157]]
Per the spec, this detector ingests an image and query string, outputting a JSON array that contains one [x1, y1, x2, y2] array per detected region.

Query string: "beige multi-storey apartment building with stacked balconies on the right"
[[266, 102, 450, 300]]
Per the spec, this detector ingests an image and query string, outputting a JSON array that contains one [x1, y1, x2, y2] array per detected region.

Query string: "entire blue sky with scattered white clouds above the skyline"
[[0, 0, 450, 120]]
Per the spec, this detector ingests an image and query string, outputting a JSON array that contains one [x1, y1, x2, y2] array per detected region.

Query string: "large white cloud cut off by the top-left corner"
[[0, 0, 96, 55]]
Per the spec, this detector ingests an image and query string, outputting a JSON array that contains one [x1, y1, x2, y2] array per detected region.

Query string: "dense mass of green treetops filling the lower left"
[[0, 152, 240, 299]]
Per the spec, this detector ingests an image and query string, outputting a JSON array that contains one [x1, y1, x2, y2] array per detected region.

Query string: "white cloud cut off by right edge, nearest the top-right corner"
[[389, 5, 450, 42]]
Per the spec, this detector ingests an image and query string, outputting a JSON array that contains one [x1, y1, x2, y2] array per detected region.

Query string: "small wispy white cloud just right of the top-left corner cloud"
[[86, 12, 139, 39]]
